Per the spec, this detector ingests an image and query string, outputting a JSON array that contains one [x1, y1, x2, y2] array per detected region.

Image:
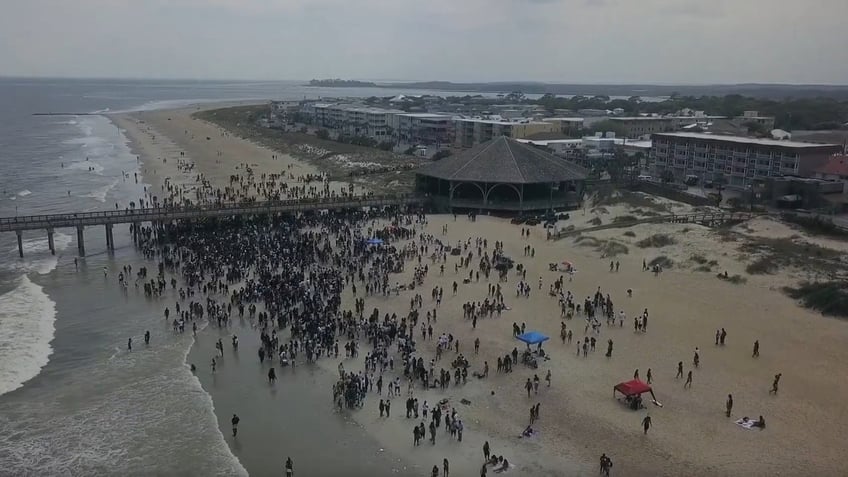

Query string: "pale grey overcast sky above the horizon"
[[0, 0, 848, 84]]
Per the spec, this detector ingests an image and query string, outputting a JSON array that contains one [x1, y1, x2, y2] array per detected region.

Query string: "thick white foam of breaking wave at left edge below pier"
[[0, 275, 56, 395]]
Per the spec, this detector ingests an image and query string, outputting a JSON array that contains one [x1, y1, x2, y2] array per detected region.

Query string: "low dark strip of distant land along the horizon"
[[309, 79, 848, 100]]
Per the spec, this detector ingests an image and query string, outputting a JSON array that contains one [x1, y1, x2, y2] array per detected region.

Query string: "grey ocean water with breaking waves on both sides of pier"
[[0, 78, 464, 476]]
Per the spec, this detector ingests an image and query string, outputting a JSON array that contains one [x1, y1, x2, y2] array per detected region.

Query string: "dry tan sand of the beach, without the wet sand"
[[116, 105, 848, 476]]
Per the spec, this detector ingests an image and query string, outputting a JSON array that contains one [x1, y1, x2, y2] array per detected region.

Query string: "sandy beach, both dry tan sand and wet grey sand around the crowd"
[[112, 105, 848, 475]]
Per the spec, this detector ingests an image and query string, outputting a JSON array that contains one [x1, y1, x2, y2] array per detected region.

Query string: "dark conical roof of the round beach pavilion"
[[416, 136, 588, 184]]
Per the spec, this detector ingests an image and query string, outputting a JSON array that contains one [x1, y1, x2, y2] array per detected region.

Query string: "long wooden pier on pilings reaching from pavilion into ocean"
[[0, 196, 424, 258]]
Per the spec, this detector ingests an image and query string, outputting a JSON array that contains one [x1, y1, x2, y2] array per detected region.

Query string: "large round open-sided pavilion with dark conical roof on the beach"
[[415, 136, 588, 213]]
